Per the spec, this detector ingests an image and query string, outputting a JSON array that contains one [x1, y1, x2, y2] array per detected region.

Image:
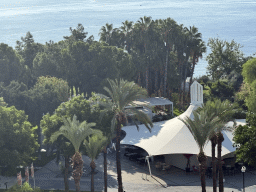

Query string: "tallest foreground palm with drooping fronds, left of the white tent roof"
[[101, 79, 153, 192]]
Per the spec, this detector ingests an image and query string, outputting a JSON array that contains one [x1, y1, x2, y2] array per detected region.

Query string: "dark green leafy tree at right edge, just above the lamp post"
[[233, 112, 256, 167]]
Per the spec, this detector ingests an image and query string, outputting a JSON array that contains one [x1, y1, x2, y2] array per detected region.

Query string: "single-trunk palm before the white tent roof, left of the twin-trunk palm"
[[179, 110, 225, 192]]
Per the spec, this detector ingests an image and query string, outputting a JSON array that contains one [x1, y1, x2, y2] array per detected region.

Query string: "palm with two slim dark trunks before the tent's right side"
[[197, 99, 236, 192]]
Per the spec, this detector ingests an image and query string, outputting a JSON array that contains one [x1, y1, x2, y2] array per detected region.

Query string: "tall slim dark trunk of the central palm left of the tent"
[[116, 118, 123, 192]]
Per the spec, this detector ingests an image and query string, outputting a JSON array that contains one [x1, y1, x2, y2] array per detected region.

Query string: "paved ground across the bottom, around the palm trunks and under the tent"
[[0, 146, 256, 192]]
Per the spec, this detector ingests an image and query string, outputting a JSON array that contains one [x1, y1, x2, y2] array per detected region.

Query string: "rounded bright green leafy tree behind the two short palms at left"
[[40, 94, 112, 160]]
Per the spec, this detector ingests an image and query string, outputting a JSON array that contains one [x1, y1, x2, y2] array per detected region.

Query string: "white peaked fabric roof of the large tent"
[[121, 105, 245, 156]]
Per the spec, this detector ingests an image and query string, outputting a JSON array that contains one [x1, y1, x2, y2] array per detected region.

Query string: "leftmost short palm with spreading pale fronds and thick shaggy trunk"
[[50, 115, 101, 191]]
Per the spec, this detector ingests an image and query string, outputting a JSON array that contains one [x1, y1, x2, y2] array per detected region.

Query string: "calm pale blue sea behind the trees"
[[0, 0, 256, 77]]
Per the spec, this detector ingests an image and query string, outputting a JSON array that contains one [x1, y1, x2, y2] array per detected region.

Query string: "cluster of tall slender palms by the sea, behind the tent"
[[99, 16, 206, 96]]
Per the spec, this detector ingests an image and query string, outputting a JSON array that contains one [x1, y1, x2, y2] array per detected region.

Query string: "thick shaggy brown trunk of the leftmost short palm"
[[72, 152, 83, 192]]
